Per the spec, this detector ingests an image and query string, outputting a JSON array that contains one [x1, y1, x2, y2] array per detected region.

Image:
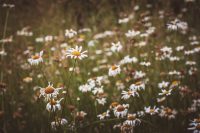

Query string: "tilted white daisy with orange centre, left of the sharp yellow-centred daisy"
[[28, 51, 43, 65]]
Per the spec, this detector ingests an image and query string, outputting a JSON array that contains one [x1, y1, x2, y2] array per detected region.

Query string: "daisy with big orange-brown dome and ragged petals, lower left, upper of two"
[[40, 82, 61, 101]]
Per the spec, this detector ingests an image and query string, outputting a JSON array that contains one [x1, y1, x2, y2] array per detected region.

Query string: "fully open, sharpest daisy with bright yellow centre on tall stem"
[[66, 46, 87, 60]]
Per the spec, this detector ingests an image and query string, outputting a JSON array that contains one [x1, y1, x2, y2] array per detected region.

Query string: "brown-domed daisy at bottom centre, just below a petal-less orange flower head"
[[114, 104, 129, 118]]
